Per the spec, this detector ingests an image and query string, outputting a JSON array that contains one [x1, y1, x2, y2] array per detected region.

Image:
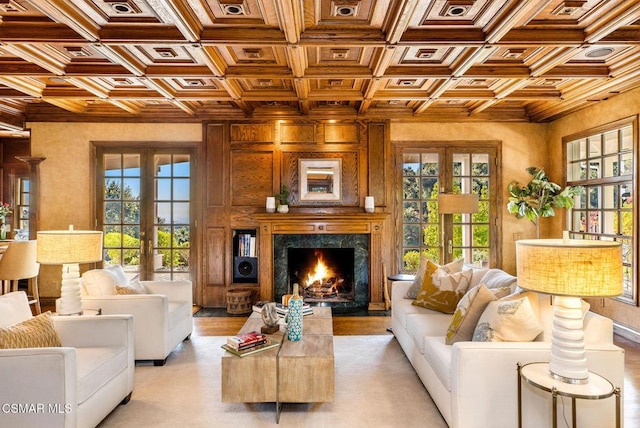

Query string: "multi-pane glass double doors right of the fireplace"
[[401, 147, 497, 272]]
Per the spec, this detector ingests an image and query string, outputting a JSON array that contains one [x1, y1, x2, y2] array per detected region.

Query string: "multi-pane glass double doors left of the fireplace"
[[97, 148, 194, 280]]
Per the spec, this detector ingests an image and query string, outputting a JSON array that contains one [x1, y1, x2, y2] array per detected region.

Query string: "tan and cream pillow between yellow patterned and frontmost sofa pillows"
[[446, 284, 511, 345]]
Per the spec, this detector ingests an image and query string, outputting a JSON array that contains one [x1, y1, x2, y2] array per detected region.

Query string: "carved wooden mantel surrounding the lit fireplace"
[[254, 212, 389, 310]]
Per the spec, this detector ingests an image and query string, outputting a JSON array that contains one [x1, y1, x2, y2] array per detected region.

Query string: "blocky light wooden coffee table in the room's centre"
[[222, 307, 335, 419]]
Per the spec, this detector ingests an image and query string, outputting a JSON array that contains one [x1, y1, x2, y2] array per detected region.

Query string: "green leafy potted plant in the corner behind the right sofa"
[[507, 166, 581, 239]]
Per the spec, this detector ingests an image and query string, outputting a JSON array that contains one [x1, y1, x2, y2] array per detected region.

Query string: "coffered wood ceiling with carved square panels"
[[0, 0, 640, 134]]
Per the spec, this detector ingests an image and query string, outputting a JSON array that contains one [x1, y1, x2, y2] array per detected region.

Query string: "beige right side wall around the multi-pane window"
[[547, 84, 640, 331]]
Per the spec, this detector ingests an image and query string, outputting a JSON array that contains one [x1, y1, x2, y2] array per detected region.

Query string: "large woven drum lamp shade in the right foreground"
[[516, 239, 622, 297]]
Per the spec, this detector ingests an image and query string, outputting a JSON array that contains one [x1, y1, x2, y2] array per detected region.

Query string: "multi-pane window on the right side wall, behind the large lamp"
[[565, 118, 637, 302]]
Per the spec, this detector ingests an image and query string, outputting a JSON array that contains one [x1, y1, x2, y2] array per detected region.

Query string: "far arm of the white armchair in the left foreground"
[[52, 314, 133, 349]]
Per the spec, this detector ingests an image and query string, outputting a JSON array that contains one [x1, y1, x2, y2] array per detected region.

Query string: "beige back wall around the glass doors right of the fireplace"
[[391, 122, 551, 274]]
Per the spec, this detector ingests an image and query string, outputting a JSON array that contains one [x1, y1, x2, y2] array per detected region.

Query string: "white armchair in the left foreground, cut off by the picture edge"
[[0, 291, 135, 428]]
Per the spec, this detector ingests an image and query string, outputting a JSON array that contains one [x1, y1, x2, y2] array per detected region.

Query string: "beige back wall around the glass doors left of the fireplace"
[[27, 122, 202, 298]]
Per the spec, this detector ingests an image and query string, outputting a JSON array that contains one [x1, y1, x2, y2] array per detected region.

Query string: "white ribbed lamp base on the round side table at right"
[[549, 296, 589, 384]]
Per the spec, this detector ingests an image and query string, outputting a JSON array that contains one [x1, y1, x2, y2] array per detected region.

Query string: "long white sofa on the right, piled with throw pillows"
[[392, 270, 624, 428]]
